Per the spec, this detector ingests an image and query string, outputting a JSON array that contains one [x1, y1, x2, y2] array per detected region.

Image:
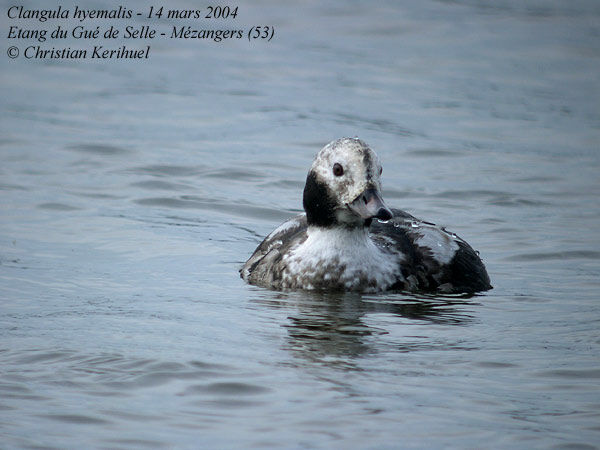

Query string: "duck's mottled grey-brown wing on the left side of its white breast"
[[240, 214, 308, 288]]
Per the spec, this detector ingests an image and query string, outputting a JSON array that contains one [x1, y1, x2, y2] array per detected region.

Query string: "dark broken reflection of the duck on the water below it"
[[251, 291, 477, 368]]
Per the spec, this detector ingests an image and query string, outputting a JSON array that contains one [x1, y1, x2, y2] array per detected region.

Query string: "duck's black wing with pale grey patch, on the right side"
[[370, 209, 491, 293]]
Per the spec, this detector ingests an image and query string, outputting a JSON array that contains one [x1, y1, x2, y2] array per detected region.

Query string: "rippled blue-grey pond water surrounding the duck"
[[0, 0, 600, 448]]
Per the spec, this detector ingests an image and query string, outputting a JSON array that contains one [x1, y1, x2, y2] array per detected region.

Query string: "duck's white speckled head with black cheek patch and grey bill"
[[303, 138, 393, 227]]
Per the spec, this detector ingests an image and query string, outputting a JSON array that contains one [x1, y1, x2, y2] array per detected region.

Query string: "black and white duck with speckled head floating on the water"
[[240, 138, 492, 294]]
